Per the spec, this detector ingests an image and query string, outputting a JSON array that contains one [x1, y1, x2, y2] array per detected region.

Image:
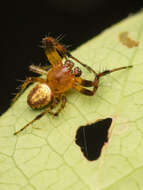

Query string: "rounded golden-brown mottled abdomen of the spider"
[[27, 83, 52, 109]]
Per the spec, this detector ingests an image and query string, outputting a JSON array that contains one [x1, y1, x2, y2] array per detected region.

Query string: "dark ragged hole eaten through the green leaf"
[[75, 118, 112, 161]]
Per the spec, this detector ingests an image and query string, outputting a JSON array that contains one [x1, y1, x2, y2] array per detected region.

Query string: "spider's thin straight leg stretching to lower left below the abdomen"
[[14, 100, 58, 135]]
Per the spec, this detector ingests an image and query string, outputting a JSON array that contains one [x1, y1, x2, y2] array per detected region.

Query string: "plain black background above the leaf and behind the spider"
[[0, 0, 143, 114]]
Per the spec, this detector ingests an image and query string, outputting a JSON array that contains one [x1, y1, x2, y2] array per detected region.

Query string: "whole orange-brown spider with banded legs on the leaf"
[[12, 37, 131, 135]]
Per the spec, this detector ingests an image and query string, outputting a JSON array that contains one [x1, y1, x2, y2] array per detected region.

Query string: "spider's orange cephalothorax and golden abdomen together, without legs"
[[27, 62, 75, 109]]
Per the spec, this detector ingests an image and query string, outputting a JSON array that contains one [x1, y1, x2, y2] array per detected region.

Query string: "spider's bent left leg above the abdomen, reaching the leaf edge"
[[11, 77, 45, 104]]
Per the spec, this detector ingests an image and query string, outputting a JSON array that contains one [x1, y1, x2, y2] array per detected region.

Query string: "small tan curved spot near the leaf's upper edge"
[[119, 32, 139, 48]]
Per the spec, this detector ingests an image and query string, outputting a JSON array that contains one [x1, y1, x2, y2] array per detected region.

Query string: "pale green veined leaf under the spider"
[[0, 12, 143, 190]]
